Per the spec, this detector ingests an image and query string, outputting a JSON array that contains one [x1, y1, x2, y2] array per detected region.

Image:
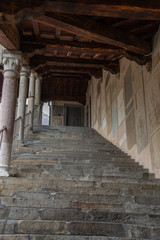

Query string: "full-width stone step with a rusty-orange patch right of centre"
[[0, 197, 160, 215]]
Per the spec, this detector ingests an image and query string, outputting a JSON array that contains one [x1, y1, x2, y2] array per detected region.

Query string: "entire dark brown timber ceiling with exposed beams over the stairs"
[[0, 0, 160, 104]]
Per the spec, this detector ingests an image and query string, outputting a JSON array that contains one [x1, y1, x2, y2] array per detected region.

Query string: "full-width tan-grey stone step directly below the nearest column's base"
[[0, 178, 160, 197]]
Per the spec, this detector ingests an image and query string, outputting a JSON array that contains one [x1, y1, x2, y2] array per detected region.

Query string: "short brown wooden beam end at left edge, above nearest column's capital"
[[0, 23, 20, 50]]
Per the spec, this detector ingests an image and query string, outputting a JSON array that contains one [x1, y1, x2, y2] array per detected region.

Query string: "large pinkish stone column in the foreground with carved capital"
[[0, 51, 21, 176]]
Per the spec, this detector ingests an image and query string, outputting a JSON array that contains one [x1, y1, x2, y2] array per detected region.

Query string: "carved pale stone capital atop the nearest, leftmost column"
[[2, 50, 22, 77]]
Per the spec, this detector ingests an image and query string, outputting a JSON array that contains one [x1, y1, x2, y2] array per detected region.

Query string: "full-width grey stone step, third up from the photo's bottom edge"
[[0, 207, 160, 227]]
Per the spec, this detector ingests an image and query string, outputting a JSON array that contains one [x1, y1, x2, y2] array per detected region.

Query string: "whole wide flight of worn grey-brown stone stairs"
[[0, 126, 160, 240]]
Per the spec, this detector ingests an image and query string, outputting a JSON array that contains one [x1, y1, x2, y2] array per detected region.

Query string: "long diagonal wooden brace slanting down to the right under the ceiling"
[[35, 14, 151, 54]]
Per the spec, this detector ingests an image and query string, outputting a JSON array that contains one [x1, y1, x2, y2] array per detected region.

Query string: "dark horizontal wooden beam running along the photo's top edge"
[[1, 0, 160, 22]]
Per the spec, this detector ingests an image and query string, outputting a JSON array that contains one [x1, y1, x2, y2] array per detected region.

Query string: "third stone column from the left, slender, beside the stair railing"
[[28, 71, 37, 130]]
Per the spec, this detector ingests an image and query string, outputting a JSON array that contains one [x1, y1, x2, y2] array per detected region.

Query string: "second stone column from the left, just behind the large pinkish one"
[[17, 66, 30, 141]]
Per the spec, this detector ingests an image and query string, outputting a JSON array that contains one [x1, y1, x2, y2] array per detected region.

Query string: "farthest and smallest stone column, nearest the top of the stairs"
[[34, 77, 42, 125]]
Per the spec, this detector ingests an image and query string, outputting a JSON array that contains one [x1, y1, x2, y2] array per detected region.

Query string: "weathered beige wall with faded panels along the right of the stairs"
[[86, 29, 160, 177]]
